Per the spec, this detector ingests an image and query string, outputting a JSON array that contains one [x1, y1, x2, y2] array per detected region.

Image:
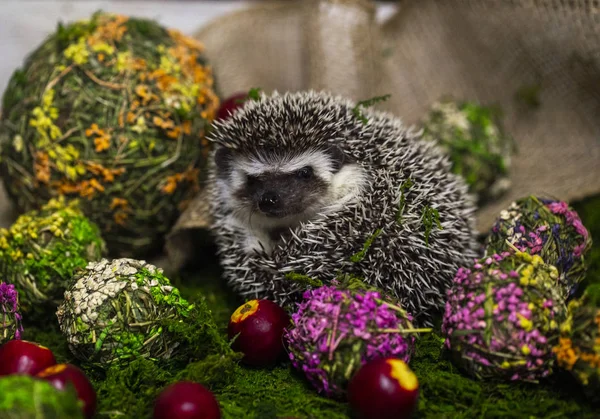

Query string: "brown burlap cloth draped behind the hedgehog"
[[167, 0, 600, 266]]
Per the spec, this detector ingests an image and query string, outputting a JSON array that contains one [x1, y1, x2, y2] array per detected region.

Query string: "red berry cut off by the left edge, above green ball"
[[0, 339, 56, 376]]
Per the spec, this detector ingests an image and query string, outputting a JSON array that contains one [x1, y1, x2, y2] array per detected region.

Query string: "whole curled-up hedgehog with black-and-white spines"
[[207, 91, 478, 325]]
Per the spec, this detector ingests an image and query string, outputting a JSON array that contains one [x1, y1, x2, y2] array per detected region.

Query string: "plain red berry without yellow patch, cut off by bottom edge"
[[152, 381, 221, 419]]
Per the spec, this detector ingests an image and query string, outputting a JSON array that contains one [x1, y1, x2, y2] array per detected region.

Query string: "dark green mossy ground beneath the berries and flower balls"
[[25, 196, 600, 419]]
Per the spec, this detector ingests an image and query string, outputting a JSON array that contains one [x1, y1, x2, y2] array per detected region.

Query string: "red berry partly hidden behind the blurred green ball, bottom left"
[[36, 364, 96, 418]]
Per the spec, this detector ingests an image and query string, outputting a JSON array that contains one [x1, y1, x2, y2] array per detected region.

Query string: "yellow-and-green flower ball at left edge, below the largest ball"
[[0, 198, 105, 313]]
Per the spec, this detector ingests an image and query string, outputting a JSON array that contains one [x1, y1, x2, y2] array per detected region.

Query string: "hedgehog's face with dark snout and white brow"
[[215, 147, 355, 227]]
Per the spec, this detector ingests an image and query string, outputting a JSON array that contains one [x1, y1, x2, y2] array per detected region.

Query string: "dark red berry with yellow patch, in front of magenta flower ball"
[[348, 358, 419, 419]]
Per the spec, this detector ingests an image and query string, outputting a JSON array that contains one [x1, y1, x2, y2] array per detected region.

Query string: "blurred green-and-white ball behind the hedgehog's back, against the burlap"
[[422, 101, 513, 203]]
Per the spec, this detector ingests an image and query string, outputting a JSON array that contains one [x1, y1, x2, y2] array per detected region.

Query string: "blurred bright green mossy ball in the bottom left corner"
[[0, 375, 84, 419]]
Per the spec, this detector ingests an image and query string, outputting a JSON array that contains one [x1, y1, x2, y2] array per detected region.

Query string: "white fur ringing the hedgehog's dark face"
[[217, 150, 367, 254]]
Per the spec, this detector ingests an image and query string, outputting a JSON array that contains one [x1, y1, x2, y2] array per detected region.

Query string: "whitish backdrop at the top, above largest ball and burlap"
[[0, 0, 394, 95]]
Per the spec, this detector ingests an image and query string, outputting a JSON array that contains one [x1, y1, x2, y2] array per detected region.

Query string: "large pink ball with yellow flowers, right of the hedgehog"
[[442, 252, 567, 382]]
